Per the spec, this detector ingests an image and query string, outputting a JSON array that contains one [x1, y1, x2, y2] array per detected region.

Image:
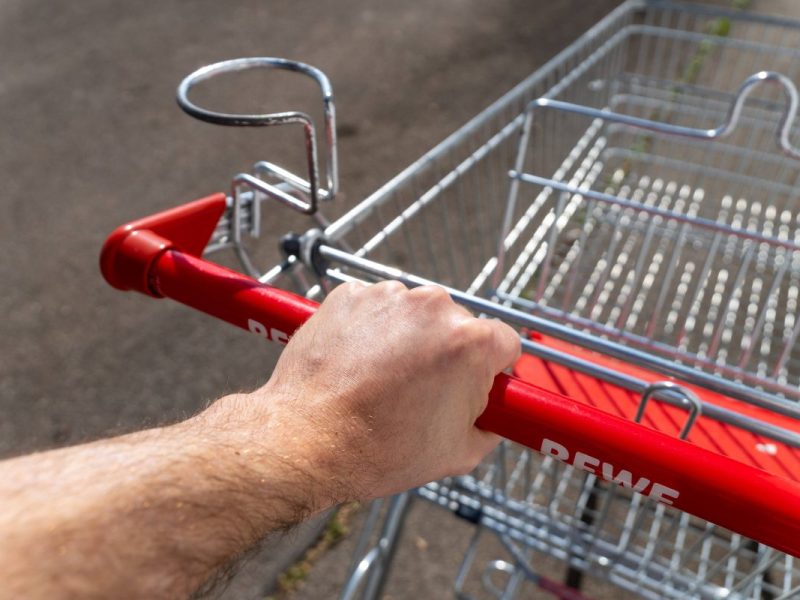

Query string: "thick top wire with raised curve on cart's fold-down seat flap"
[[524, 71, 800, 158]]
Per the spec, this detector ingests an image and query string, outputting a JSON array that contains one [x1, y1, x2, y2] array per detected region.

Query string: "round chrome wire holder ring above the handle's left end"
[[177, 57, 339, 214]]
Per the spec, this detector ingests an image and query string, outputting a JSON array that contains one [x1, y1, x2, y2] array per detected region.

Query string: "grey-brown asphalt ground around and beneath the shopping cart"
[[0, 0, 792, 598]]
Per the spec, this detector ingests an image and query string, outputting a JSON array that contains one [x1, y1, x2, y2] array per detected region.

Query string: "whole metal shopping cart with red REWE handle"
[[101, 0, 800, 599]]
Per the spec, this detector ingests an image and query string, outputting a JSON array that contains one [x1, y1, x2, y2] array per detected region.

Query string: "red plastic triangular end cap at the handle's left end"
[[100, 193, 226, 297]]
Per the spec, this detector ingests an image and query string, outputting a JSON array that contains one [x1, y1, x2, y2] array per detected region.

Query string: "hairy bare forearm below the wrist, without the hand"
[[0, 398, 335, 598]]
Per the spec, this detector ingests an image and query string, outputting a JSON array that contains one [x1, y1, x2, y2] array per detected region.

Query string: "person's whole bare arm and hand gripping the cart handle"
[[0, 282, 520, 598]]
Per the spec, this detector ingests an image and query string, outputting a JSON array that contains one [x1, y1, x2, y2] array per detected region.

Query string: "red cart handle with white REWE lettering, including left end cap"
[[100, 194, 800, 557]]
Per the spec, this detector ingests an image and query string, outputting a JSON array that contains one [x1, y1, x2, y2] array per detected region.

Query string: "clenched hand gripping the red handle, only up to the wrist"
[[231, 282, 520, 501]]
